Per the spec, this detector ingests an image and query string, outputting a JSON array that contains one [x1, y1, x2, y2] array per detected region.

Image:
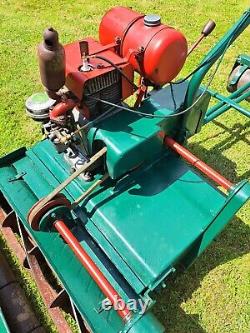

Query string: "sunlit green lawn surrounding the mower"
[[0, 0, 250, 333]]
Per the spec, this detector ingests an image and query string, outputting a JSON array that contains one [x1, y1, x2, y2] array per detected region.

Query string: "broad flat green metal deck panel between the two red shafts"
[[86, 150, 225, 288]]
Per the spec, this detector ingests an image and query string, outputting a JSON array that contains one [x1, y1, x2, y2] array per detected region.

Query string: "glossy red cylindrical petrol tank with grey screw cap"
[[99, 7, 187, 86]]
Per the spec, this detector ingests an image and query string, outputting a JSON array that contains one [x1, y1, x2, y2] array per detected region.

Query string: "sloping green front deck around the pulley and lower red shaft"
[[0, 141, 164, 333]]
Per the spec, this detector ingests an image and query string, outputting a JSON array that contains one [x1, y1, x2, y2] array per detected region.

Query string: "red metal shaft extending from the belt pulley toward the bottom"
[[54, 220, 131, 321]]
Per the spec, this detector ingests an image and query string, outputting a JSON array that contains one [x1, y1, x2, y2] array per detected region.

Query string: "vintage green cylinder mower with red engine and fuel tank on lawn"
[[0, 7, 250, 333]]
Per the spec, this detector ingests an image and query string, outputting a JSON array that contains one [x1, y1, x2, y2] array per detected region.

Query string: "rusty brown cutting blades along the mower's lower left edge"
[[0, 207, 72, 333]]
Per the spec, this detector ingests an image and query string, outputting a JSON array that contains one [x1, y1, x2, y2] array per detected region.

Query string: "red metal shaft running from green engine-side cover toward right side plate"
[[163, 134, 233, 191]]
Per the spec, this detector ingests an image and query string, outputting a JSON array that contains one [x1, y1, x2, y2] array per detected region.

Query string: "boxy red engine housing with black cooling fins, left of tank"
[[64, 38, 134, 119]]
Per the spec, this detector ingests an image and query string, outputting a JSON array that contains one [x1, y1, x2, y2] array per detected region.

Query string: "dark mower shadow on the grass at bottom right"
[[154, 217, 250, 333]]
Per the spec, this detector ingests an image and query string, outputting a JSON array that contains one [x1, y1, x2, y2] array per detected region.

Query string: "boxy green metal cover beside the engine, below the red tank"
[[88, 86, 186, 179]]
